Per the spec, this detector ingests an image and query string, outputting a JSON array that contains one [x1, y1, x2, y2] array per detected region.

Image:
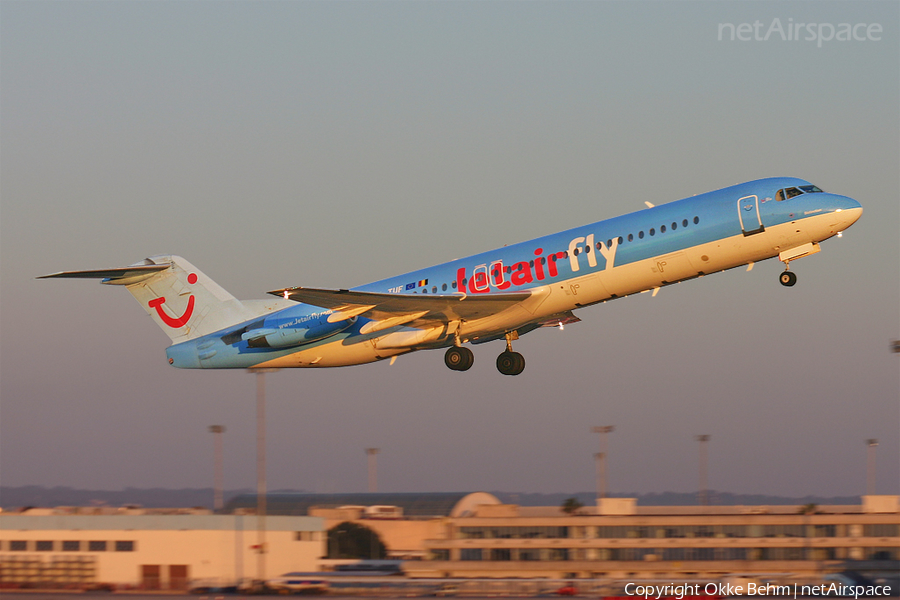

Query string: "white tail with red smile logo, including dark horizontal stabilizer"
[[38, 256, 259, 343]]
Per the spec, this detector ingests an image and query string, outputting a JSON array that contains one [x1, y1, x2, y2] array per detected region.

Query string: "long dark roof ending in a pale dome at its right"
[[222, 492, 500, 517]]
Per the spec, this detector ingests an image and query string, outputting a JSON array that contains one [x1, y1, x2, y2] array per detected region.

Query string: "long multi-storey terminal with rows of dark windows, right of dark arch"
[[405, 496, 900, 580]]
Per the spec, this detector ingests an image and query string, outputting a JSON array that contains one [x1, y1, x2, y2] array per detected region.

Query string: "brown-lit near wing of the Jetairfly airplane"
[[269, 287, 531, 333]]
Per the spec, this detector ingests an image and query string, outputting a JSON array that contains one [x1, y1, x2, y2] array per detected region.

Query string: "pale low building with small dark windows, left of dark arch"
[[0, 508, 325, 590]]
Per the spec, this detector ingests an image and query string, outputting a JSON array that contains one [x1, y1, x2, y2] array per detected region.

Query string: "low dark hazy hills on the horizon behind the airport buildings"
[[0, 485, 862, 510]]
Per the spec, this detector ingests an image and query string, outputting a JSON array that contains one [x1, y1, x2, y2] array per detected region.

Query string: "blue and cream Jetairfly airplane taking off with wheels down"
[[39, 177, 862, 375]]
